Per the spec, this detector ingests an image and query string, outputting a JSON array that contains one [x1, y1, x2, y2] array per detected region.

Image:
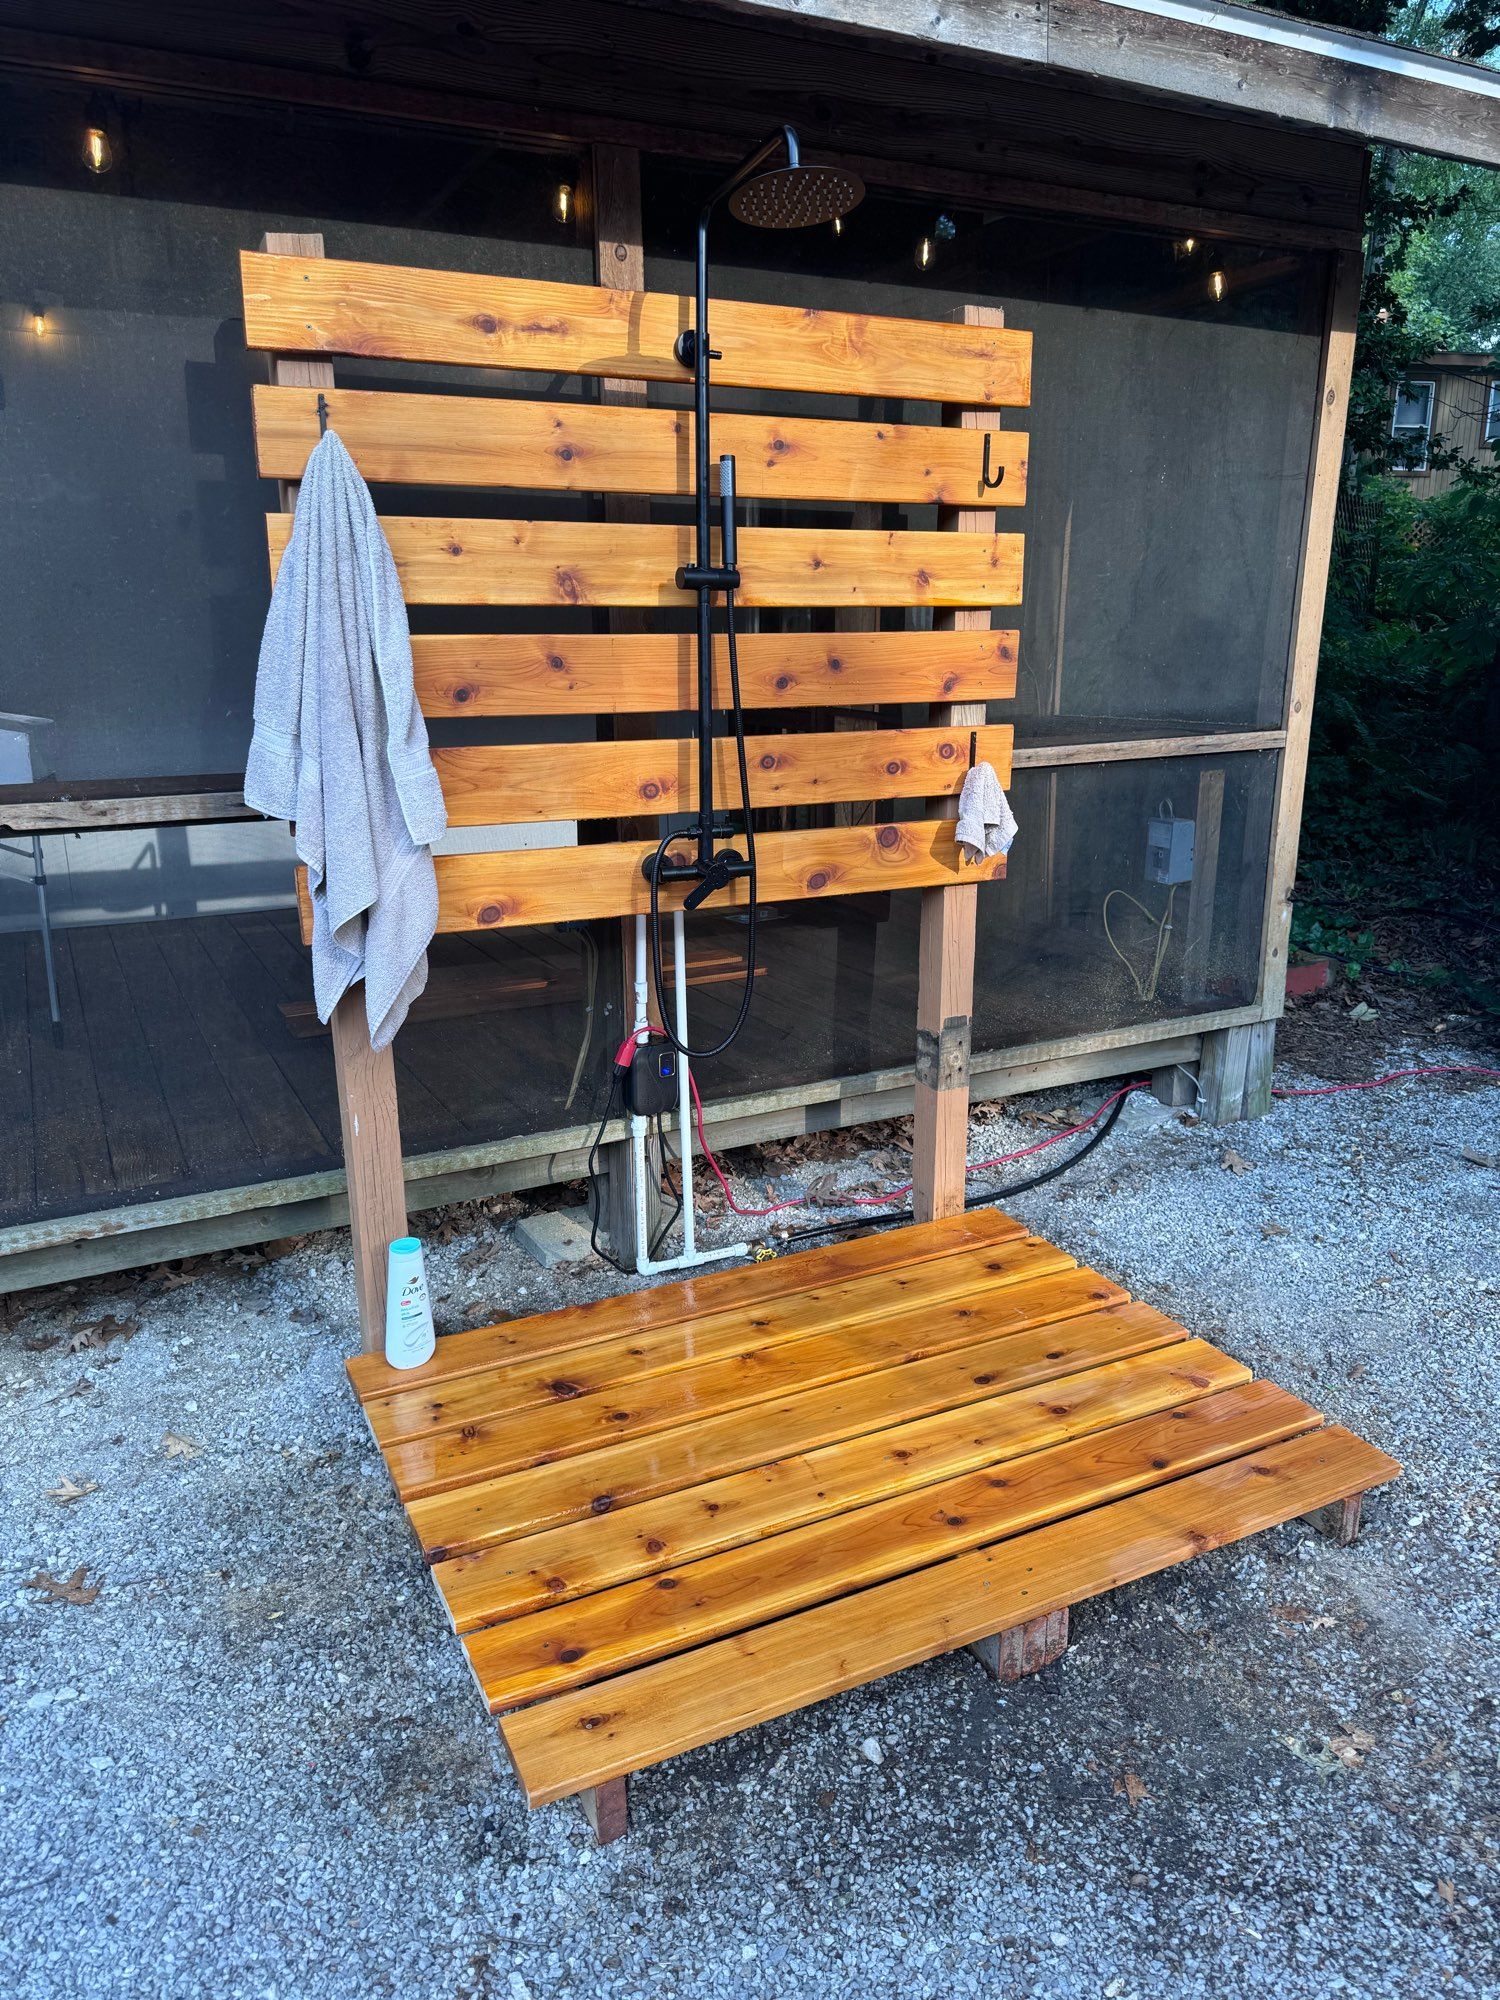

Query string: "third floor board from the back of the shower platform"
[[386, 1252, 1126, 1500]]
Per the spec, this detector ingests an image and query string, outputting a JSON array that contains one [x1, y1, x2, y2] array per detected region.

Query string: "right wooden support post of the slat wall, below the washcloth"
[[912, 306, 1006, 1222]]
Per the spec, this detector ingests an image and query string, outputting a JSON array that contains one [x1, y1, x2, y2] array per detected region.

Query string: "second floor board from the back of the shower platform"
[[364, 1236, 1078, 1450]]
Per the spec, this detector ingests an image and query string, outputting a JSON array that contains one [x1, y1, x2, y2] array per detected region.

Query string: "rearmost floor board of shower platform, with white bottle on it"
[[346, 1208, 1026, 1402]]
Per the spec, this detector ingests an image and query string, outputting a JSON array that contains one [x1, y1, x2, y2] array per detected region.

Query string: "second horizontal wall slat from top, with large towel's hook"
[[254, 384, 1028, 506]]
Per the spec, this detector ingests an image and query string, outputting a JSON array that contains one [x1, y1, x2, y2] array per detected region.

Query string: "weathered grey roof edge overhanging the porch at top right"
[[700, 0, 1500, 166]]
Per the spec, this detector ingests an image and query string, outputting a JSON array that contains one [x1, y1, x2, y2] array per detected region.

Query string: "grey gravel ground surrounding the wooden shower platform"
[[0, 1044, 1500, 2000]]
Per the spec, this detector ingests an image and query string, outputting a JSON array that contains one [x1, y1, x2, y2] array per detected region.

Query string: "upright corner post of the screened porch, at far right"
[[1260, 250, 1364, 1020]]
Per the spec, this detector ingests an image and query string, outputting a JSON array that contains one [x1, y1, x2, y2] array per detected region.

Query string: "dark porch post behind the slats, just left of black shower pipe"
[[590, 144, 662, 1262]]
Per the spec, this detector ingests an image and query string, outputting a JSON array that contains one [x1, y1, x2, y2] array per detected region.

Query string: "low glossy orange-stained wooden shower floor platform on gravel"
[[348, 1210, 1400, 1838]]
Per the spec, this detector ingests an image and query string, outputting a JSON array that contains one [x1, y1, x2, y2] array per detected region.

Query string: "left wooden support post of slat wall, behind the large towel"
[[260, 232, 406, 1354]]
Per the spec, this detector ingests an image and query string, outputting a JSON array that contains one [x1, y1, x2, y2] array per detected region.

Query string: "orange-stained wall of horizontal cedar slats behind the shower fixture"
[[242, 246, 1030, 1346]]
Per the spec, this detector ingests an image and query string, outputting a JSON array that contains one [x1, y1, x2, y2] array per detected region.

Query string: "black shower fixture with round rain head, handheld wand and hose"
[[644, 126, 864, 1056]]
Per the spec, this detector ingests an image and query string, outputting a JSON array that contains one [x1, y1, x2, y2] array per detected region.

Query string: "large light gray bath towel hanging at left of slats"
[[244, 430, 448, 1048]]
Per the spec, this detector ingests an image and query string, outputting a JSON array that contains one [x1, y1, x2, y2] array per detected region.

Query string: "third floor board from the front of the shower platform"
[[432, 1340, 1250, 1632]]
